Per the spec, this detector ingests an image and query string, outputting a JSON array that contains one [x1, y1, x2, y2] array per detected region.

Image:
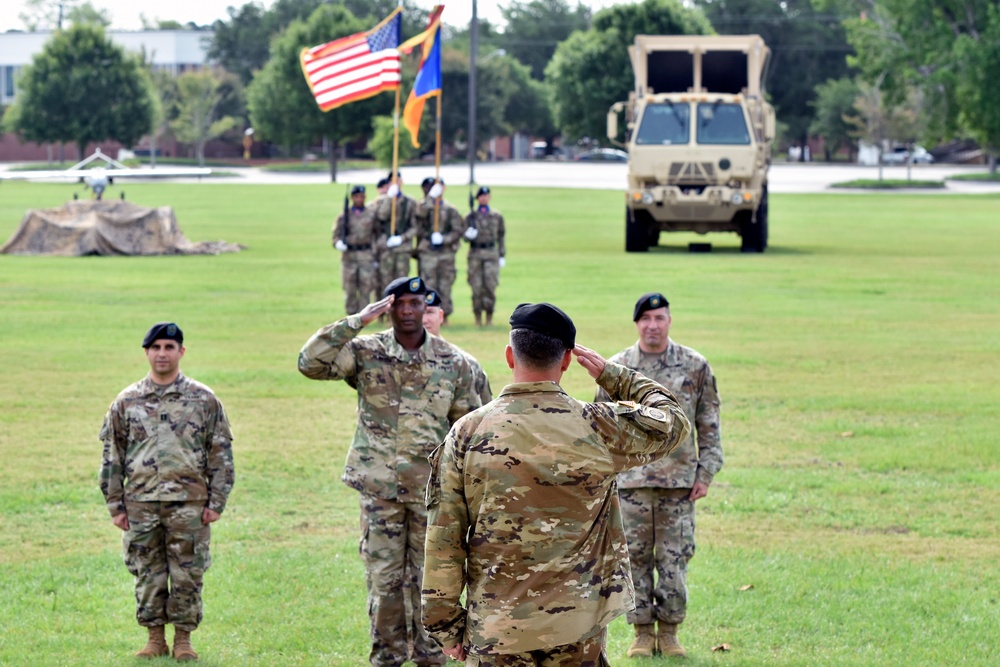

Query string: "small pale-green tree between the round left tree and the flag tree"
[[170, 70, 242, 166]]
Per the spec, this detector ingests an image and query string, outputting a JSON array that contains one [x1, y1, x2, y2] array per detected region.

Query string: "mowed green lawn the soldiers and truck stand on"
[[0, 183, 1000, 666]]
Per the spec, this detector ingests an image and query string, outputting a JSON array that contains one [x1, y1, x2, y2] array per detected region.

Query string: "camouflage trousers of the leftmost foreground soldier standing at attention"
[[122, 501, 212, 632]]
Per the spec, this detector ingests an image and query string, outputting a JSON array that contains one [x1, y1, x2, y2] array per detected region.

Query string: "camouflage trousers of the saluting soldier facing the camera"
[[360, 494, 446, 667]]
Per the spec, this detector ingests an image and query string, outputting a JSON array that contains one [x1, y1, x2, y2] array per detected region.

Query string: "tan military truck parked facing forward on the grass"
[[607, 35, 775, 252]]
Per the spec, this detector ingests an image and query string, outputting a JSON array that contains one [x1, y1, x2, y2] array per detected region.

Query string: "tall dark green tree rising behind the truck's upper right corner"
[[695, 0, 851, 155]]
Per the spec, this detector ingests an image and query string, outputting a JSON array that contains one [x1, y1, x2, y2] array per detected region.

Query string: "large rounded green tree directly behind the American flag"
[[247, 5, 393, 181]]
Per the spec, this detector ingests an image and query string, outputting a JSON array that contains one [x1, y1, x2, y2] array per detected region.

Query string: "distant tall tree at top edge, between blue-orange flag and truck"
[[497, 0, 591, 81]]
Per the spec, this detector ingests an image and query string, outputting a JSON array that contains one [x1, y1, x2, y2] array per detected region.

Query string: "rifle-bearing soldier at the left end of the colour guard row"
[[333, 185, 379, 313]]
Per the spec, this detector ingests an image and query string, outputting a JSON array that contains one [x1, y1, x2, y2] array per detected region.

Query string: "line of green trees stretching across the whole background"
[[3, 0, 1000, 175]]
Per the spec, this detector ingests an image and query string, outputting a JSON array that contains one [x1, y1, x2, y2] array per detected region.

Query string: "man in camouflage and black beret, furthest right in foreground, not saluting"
[[597, 292, 723, 657]]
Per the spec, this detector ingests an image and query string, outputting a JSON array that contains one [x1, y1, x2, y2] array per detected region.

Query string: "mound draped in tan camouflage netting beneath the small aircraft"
[[0, 200, 244, 256]]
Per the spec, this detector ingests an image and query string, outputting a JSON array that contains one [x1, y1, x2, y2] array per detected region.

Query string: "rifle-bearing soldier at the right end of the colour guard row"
[[465, 185, 507, 326]]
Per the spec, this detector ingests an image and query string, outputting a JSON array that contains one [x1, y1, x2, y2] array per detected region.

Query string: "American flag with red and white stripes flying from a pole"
[[299, 9, 402, 111]]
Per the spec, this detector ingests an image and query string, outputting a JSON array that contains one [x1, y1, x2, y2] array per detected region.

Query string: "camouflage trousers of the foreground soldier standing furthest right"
[[618, 488, 695, 625]]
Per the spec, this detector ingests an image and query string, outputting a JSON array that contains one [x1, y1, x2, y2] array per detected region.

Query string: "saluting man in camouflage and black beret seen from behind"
[[423, 303, 690, 667]]
